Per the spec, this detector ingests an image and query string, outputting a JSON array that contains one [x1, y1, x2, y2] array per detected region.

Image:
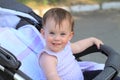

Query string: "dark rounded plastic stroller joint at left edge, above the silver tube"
[[0, 46, 21, 69]]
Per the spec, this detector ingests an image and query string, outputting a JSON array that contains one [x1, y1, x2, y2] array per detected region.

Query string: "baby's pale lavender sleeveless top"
[[39, 43, 84, 80]]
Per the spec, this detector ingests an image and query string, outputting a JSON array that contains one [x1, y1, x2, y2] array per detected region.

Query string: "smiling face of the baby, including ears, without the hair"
[[42, 18, 73, 52]]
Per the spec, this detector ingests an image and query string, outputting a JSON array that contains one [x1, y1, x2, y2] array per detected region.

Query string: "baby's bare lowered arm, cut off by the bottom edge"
[[39, 52, 60, 80]]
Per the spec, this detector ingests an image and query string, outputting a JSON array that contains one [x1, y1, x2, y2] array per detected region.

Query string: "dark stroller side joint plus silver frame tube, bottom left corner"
[[0, 46, 32, 80]]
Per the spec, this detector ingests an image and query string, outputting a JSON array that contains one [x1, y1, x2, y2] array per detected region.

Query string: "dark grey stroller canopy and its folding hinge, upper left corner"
[[0, 0, 42, 31]]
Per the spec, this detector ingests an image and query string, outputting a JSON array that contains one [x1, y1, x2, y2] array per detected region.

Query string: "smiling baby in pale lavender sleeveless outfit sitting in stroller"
[[39, 8, 104, 80]]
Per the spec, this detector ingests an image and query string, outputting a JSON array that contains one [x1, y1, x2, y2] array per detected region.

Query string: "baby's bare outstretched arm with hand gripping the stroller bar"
[[71, 37, 103, 54]]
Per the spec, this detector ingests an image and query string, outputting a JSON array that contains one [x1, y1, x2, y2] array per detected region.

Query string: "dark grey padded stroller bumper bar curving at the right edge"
[[93, 45, 120, 80]]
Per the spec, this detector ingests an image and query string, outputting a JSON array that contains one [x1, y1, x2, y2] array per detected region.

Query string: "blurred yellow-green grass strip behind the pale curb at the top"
[[17, 0, 120, 16]]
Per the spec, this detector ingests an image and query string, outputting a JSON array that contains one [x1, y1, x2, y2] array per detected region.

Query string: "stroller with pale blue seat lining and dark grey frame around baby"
[[0, 0, 120, 80]]
